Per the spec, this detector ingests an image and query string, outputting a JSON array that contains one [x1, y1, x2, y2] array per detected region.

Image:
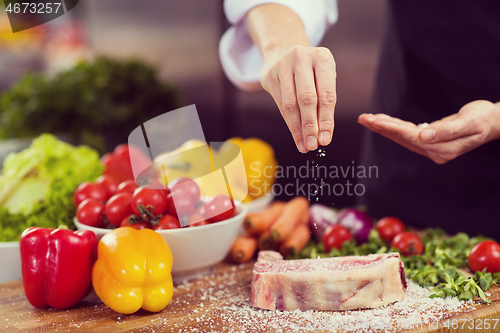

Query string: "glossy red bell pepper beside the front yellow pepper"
[[19, 227, 97, 309]]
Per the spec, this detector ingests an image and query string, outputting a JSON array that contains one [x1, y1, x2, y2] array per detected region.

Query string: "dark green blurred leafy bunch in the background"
[[0, 57, 182, 153]]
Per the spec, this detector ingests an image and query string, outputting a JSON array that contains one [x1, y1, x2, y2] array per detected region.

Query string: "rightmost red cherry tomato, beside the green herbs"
[[469, 240, 500, 274]]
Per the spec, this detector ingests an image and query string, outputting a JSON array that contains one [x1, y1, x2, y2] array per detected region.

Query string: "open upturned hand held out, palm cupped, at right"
[[358, 100, 500, 164]]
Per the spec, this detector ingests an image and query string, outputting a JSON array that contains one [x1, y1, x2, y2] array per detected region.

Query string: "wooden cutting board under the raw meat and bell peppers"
[[0, 263, 500, 333]]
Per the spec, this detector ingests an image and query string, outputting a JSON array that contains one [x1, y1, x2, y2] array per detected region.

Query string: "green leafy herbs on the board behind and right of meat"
[[291, 228, 500, 303]]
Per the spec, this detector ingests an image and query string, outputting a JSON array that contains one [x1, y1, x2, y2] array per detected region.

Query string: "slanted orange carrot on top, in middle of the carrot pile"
[[269, 197, 309, 242]]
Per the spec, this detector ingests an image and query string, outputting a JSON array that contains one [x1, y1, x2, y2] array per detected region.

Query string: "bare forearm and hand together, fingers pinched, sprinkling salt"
[[247, 4, 337, 153]]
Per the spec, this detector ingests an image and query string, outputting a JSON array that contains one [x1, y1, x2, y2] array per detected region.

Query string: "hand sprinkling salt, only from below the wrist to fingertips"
[[260, 46, 337, 153]]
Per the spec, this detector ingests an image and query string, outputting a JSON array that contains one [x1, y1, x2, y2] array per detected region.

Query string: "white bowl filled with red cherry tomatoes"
[[75, 204, 248, 281]]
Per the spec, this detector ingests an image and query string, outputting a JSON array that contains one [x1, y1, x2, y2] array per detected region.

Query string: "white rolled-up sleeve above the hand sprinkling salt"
[[219, 0, 338, 90]]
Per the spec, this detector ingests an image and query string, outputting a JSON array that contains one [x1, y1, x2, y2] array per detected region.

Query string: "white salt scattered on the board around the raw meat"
[[167, 264, 474, 332]]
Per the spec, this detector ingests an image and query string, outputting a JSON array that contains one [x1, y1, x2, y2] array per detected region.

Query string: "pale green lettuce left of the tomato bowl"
[[0, 134, 103, 241]]
